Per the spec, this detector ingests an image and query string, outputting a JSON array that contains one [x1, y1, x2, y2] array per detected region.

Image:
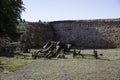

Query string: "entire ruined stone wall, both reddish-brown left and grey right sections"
[[23, 19, 120, 48]]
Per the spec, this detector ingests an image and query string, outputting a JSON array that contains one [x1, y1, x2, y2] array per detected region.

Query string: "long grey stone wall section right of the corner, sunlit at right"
[[50, 19, 120, 48]]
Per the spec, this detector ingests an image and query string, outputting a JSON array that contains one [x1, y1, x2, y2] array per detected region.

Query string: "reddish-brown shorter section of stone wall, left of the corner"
[[20, 22, 53, 48]]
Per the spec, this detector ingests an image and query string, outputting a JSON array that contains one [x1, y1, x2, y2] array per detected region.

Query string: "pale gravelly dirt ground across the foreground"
[[0, 49, 120, 80]]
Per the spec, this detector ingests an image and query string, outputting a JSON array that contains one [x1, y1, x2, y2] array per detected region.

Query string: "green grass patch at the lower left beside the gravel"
[[0, 57, 33, 71]]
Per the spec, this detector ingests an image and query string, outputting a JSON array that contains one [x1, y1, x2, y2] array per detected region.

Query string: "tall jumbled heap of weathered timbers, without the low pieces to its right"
[[32, 41, 71, 59]]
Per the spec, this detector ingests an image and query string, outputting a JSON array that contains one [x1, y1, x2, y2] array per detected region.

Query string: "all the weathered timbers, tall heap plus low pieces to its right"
[[32, 41, 102, 59]]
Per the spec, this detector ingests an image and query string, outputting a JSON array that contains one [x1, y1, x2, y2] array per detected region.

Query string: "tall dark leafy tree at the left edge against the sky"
[[0, 0, 25, 36]]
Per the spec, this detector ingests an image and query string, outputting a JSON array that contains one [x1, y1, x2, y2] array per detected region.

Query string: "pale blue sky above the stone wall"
[[21, 0, 120, 22]]
